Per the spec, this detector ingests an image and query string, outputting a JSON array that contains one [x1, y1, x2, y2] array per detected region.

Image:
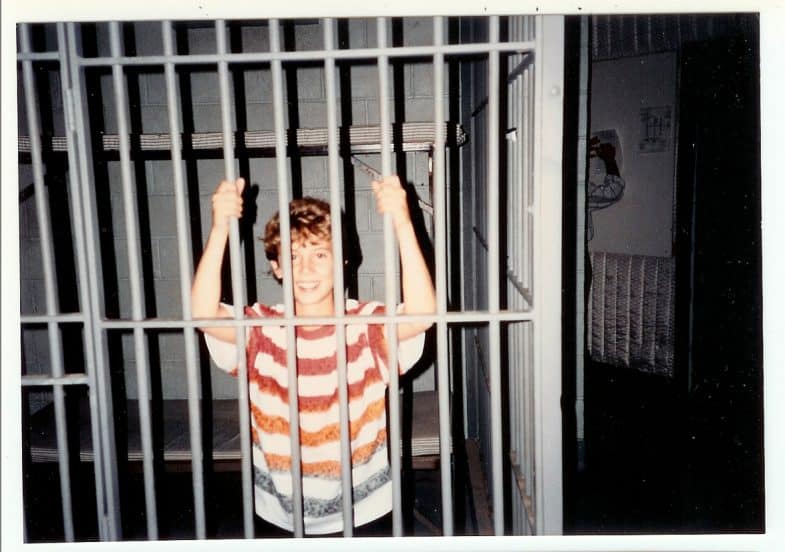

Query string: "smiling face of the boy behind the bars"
[[270, 238, 335, 316]]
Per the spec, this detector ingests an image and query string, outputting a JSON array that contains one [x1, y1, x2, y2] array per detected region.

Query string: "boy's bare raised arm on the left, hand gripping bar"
[[191, 178, 245, 342]]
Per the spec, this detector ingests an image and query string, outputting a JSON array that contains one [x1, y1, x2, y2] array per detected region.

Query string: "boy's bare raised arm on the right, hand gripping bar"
[[371, 176, 436, 340]]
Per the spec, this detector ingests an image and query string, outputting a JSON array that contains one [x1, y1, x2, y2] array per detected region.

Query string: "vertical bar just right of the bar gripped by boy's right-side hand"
[[433, 17, 455, 536]]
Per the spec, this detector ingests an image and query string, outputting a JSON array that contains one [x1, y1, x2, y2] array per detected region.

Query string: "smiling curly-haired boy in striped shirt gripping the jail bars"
[[191, 176, 436, 534]]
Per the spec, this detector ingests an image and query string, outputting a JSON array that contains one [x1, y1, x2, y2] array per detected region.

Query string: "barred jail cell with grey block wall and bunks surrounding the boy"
[[17, 16, 562, 541]]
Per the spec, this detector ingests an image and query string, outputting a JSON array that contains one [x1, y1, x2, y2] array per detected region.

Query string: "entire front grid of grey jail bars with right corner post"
[[19, 16, 562, 540]]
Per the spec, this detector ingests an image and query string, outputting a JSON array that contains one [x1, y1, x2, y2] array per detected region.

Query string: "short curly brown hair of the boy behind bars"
[[262, 197, 332, 261]]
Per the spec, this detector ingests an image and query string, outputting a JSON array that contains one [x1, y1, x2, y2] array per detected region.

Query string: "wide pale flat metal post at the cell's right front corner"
[[534, 16, 564, 535]]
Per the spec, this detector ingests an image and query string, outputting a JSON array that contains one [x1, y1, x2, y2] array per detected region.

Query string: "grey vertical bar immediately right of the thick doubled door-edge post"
[[109, 21, 158, 540]]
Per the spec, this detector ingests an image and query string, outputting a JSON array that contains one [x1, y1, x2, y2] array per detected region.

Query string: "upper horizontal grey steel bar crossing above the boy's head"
[[77, 41, 534, 67]]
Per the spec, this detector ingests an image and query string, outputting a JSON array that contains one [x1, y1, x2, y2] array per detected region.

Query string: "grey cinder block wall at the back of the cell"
[[20, 18, 447, 404]]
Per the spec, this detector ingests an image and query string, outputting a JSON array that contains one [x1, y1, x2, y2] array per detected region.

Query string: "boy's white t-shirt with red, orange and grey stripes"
[[205, 299, 425, 534]]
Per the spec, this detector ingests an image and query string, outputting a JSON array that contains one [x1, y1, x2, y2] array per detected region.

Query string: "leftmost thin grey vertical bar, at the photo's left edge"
[[19, 24, 74, 542]]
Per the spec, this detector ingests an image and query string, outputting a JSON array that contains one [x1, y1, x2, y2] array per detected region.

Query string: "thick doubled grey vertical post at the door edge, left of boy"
[[63, 23, 121, 540]]
